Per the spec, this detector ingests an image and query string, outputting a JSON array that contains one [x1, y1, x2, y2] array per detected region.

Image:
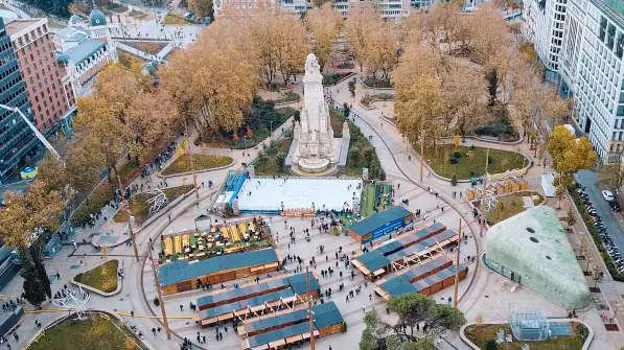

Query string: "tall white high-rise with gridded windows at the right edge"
[[561, 0, 624, 163]]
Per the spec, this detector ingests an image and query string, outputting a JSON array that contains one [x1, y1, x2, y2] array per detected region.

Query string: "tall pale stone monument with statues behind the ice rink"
[[287, 54, 350, 173]]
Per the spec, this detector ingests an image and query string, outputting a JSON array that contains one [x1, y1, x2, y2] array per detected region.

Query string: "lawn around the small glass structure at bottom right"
[[465, 323, 587, 350]]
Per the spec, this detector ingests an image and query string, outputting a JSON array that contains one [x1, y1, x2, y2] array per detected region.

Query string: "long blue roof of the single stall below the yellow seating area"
[[158, 249, 278, 287]]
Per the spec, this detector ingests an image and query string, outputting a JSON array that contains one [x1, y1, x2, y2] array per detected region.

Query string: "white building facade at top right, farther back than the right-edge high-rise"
[[522, 0, 570, 82]]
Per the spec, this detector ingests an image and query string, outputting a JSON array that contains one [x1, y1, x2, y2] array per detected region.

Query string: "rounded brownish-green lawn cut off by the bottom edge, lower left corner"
[[28, 314, 147, 350]]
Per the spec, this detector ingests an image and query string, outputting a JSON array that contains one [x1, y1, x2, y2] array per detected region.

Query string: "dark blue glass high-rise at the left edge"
[[0, 17, 42, 182]]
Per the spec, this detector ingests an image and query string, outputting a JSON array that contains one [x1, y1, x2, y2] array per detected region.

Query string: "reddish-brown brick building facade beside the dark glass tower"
[[6, 18, 75, 134]]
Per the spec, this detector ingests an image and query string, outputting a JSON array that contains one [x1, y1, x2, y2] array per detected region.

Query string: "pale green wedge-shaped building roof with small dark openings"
[[485, 206, 589, 308]]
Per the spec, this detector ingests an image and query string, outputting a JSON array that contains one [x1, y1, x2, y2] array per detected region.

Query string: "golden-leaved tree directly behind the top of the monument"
[[305, 3, 343, 72]]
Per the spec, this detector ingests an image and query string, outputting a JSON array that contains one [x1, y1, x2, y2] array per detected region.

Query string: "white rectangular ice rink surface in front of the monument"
[[238, 178, 362, 211]]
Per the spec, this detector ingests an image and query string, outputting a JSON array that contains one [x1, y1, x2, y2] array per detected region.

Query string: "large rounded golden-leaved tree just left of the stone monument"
[[161, 24, 256, 137]]
